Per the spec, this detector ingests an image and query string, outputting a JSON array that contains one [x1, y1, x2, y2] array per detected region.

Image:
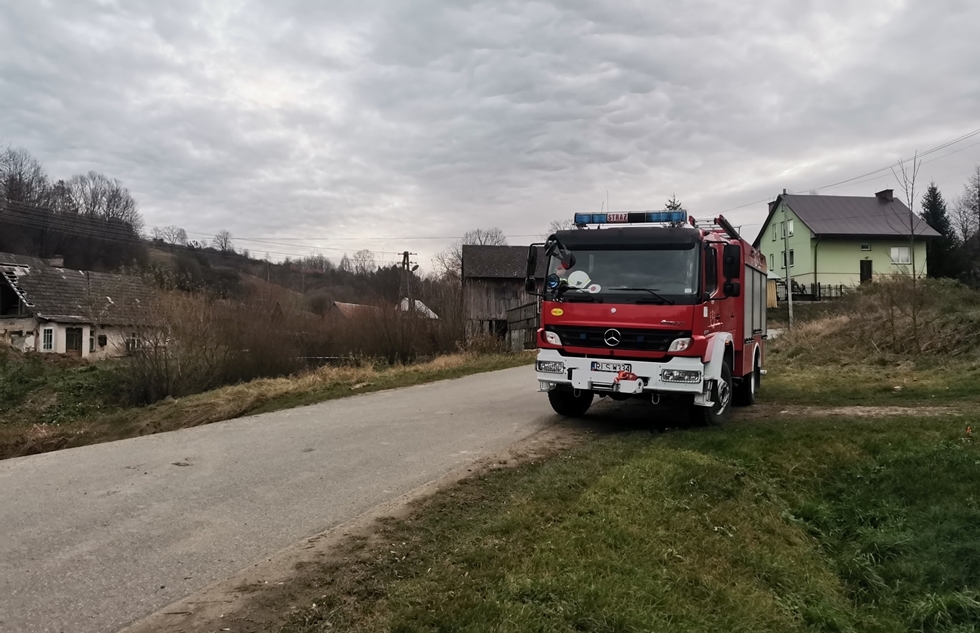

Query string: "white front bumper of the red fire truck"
[[537, 349, 706, 396]]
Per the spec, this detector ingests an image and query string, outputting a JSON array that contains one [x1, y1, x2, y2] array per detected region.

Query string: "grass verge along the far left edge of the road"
[[0, 353, 533, 459]]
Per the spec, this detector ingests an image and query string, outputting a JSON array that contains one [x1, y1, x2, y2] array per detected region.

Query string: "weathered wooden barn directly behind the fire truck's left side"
[[463, 244, 547, 338]]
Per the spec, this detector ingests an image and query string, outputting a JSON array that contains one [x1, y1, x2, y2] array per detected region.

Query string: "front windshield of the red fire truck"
[[548, 244, 699, 303]]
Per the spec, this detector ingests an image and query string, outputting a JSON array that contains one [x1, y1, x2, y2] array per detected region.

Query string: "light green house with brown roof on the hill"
[[753, 189, 939, 296]]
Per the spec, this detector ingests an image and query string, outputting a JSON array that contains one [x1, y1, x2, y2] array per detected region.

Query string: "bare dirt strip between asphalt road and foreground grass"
[[120, 424, 591, 633]]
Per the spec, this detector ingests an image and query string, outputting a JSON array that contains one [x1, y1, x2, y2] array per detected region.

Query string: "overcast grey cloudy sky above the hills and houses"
[[0, 0, 980, 269]]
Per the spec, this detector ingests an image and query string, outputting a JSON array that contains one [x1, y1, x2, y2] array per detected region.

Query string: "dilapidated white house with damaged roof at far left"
[[0, 253, 150, 360]]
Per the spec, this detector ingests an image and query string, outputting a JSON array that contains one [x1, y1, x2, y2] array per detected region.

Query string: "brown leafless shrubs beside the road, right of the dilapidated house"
[[127, 291, 468, 404]]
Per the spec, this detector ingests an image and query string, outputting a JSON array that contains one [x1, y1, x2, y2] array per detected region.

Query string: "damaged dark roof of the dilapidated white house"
[[0, 253, 152, 325]]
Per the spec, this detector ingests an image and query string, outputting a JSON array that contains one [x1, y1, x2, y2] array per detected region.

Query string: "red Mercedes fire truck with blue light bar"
[[525, 211, 767, 424]]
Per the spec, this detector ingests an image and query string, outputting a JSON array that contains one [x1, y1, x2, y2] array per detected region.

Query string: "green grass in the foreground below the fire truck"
[[281, 418, 980, 633]]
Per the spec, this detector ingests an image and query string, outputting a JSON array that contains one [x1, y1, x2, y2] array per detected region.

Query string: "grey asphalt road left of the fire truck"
[[0, 367, 555, 633]]
